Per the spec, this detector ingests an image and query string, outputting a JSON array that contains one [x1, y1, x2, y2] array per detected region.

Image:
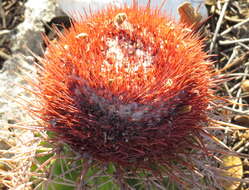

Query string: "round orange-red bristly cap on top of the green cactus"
[[33, 3, 226, 189]]
